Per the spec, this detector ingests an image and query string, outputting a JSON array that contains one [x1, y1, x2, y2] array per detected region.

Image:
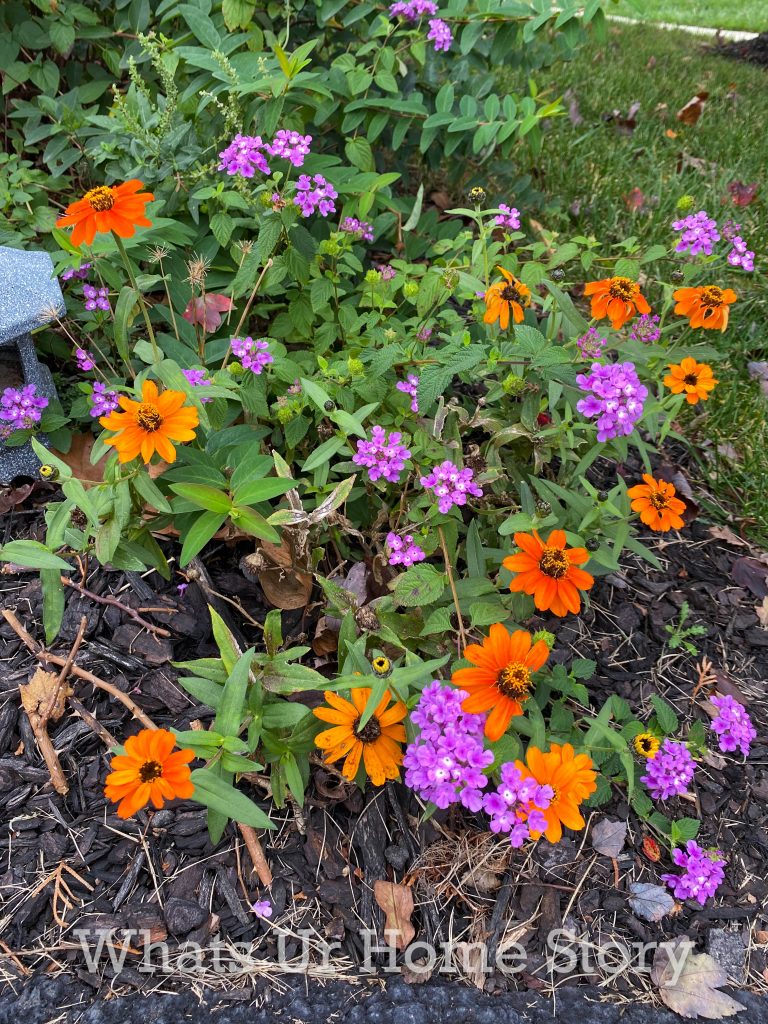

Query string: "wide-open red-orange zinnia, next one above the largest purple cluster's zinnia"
[[502, 529, 595, 615]]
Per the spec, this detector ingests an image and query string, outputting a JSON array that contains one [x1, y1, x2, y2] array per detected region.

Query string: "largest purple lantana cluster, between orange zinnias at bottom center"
[[402, 680, 494, 812]]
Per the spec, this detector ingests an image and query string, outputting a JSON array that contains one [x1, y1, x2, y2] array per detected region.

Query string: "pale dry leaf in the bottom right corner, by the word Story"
[[650, 936, 744, 1021]]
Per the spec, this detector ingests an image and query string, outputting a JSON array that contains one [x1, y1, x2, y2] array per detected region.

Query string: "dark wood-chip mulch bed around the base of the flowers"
[[0, 462, 768, 997]]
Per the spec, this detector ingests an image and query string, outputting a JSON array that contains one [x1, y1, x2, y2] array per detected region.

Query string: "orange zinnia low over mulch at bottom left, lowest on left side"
[[104, 729, 195, 818]]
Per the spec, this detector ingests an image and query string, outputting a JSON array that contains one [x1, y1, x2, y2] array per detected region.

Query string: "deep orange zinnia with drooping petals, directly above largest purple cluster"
[[452, 623, 549, 742]]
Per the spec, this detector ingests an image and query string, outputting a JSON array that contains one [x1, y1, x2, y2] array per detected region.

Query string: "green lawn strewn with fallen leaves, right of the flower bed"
[[512, 19, 768, 544]]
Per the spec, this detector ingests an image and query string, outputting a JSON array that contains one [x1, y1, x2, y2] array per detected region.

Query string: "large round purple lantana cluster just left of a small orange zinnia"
[[577, 362, 648, 441]]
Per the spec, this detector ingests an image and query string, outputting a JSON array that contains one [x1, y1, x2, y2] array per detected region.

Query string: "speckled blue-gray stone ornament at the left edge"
[[0, 246, 65, 484]]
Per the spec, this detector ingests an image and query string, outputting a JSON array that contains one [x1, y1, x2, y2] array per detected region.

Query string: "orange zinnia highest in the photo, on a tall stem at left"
[[56, 178, 155, 246]]
